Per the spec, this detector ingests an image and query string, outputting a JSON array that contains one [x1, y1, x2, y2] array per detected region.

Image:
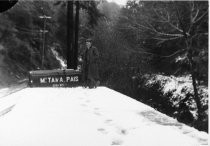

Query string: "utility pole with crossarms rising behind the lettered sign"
[[39, 15, 52, 69]]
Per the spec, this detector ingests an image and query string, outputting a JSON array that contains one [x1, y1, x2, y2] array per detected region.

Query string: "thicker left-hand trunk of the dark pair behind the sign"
[[67, 0, 74, 69]]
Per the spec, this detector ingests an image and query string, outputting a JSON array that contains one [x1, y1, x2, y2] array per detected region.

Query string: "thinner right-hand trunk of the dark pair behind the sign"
[[74, 1, 80, 69]]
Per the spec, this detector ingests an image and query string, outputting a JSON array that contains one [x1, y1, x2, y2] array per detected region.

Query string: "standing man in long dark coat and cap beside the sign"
[[82, 39, 100, 88]]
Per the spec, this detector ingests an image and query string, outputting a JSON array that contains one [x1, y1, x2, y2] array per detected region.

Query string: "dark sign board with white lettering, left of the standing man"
[[29, 69, 82, 87]]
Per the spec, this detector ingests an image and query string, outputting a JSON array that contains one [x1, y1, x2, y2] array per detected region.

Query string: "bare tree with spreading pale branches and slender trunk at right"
[[125, 0, 208, 118]]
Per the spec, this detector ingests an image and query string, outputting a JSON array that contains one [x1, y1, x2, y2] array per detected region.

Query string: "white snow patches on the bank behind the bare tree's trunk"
[[145, 75, 208, 118]]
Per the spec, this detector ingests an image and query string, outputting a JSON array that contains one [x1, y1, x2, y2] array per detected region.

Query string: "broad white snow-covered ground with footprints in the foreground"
[[0, 87, 208, 146]]
